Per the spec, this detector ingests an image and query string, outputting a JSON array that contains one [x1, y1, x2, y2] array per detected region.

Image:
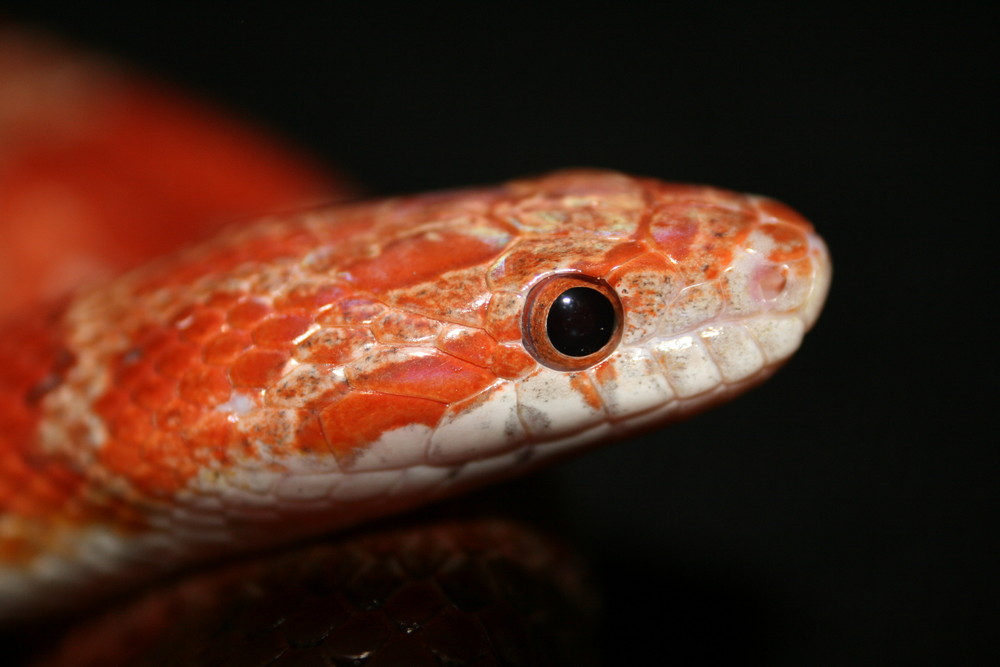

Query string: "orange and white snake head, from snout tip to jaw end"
[[135, 170, 830, 531]]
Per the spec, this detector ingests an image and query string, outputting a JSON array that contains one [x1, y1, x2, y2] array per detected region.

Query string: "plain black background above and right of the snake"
[[6, 2, 1000, 665]]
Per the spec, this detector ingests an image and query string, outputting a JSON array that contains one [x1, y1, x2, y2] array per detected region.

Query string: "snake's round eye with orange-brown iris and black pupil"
[[521, 273, 623, 371]]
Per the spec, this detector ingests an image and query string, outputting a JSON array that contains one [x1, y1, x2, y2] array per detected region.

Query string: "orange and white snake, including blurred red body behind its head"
[[0, 27, 831, 664]]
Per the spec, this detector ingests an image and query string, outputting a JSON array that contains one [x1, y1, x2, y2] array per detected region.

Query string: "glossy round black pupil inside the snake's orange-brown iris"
[[545, 287, 615, 357]]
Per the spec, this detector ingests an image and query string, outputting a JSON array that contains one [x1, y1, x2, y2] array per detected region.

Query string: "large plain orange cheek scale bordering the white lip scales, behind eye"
[[319, 391, 447, 454]]
